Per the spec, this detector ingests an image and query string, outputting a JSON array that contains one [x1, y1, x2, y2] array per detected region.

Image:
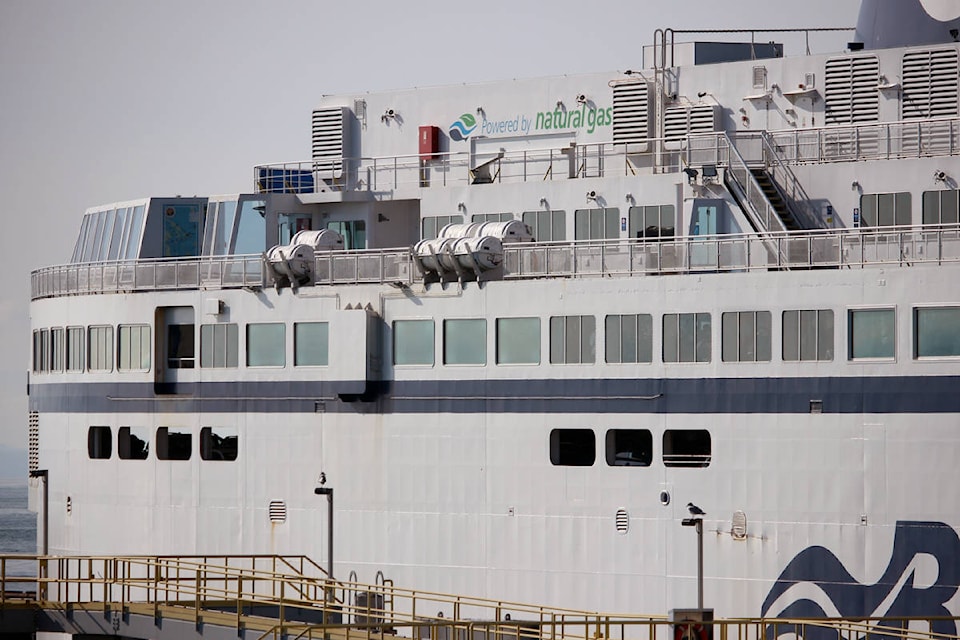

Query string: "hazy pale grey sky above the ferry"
[[0, 0, 859, 449]]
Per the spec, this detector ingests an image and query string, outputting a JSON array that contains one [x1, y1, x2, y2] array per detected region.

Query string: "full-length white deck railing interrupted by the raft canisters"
[[31, 224, 960, 299]]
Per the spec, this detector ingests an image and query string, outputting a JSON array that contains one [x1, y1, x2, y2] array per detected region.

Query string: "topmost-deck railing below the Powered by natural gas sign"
[[254, 139, 683, 194]]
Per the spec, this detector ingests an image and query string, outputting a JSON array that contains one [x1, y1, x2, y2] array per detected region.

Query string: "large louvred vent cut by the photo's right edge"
[[902, 49, 958, 120]]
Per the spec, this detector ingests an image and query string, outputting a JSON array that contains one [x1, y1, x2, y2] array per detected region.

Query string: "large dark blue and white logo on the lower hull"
[[763, 522, 960, 640]]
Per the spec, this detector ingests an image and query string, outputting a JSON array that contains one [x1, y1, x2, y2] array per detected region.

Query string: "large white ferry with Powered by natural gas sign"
[[22, 0, 960, 634]]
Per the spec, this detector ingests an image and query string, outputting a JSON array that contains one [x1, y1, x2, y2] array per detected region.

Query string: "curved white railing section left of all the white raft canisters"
[[30, 255, 264, 299]]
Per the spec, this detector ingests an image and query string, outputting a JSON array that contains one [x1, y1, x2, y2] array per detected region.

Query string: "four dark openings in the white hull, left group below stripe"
[[87, 426, 239, 462]]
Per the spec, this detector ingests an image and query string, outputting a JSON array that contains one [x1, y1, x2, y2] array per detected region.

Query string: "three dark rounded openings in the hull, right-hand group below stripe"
[[550, 429, 712, 467]]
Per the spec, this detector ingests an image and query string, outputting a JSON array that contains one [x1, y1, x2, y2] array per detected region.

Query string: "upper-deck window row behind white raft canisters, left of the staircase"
[[421, 204, 677, 242]]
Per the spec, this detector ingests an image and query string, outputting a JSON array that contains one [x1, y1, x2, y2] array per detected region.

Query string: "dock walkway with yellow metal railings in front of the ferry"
[[0, 556, 960, 640]]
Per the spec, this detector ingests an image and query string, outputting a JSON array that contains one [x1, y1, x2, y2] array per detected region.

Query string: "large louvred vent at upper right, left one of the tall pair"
[[824, 56, 880, 124]]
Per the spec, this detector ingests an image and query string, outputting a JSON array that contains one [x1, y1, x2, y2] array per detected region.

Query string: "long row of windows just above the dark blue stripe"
[[33, 307, 960, 373]]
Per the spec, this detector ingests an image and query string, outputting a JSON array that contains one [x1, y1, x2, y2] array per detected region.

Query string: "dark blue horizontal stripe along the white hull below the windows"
[[30, 376, 960, 414]]
